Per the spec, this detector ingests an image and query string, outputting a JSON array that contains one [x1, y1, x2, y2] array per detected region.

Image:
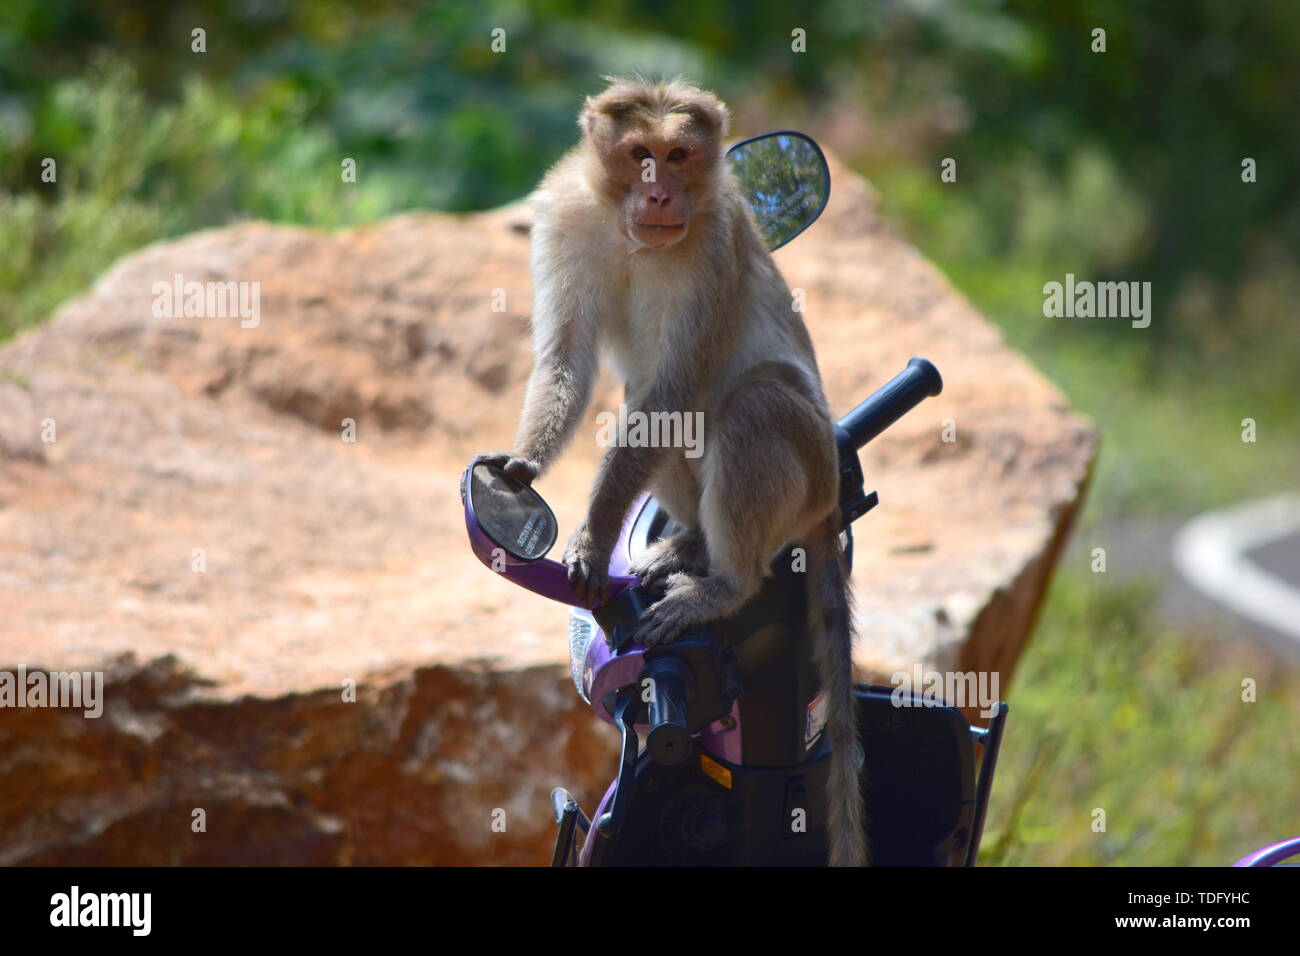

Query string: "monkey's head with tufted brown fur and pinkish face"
[[579, 77, 729, 248]]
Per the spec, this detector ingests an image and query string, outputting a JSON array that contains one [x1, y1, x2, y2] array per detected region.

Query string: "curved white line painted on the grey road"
[[1173, 494, 1300, 641]]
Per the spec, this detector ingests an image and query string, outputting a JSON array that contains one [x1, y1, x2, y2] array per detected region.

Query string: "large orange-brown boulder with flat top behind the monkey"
[[0, 153, 1095, 864]]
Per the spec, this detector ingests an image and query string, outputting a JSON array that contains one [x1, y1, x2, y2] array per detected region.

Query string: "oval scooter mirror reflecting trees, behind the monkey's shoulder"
[[727, 133, 831, 248]]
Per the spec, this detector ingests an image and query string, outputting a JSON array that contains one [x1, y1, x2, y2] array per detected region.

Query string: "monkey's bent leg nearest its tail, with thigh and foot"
[[637, 381, 837, 644]]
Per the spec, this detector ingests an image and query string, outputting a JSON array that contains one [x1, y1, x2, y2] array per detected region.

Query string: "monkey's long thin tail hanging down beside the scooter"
[[809, 511, 868, 866]]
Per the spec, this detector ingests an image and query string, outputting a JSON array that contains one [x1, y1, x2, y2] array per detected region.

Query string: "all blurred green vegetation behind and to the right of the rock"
[[0, 0, 1300, 864]]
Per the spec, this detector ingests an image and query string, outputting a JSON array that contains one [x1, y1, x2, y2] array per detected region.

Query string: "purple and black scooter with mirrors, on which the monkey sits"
[[460, 131, 1006, 866]]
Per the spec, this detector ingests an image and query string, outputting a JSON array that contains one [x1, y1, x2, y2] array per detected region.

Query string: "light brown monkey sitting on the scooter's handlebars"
[[488, 77, 867, 866]]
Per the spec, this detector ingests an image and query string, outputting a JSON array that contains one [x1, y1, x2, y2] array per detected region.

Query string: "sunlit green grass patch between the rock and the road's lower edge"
[[980, 570, 1300, 866]]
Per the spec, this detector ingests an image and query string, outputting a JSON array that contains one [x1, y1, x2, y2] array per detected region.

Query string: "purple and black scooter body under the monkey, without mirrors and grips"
[[556, 498, 1001, 866]]
